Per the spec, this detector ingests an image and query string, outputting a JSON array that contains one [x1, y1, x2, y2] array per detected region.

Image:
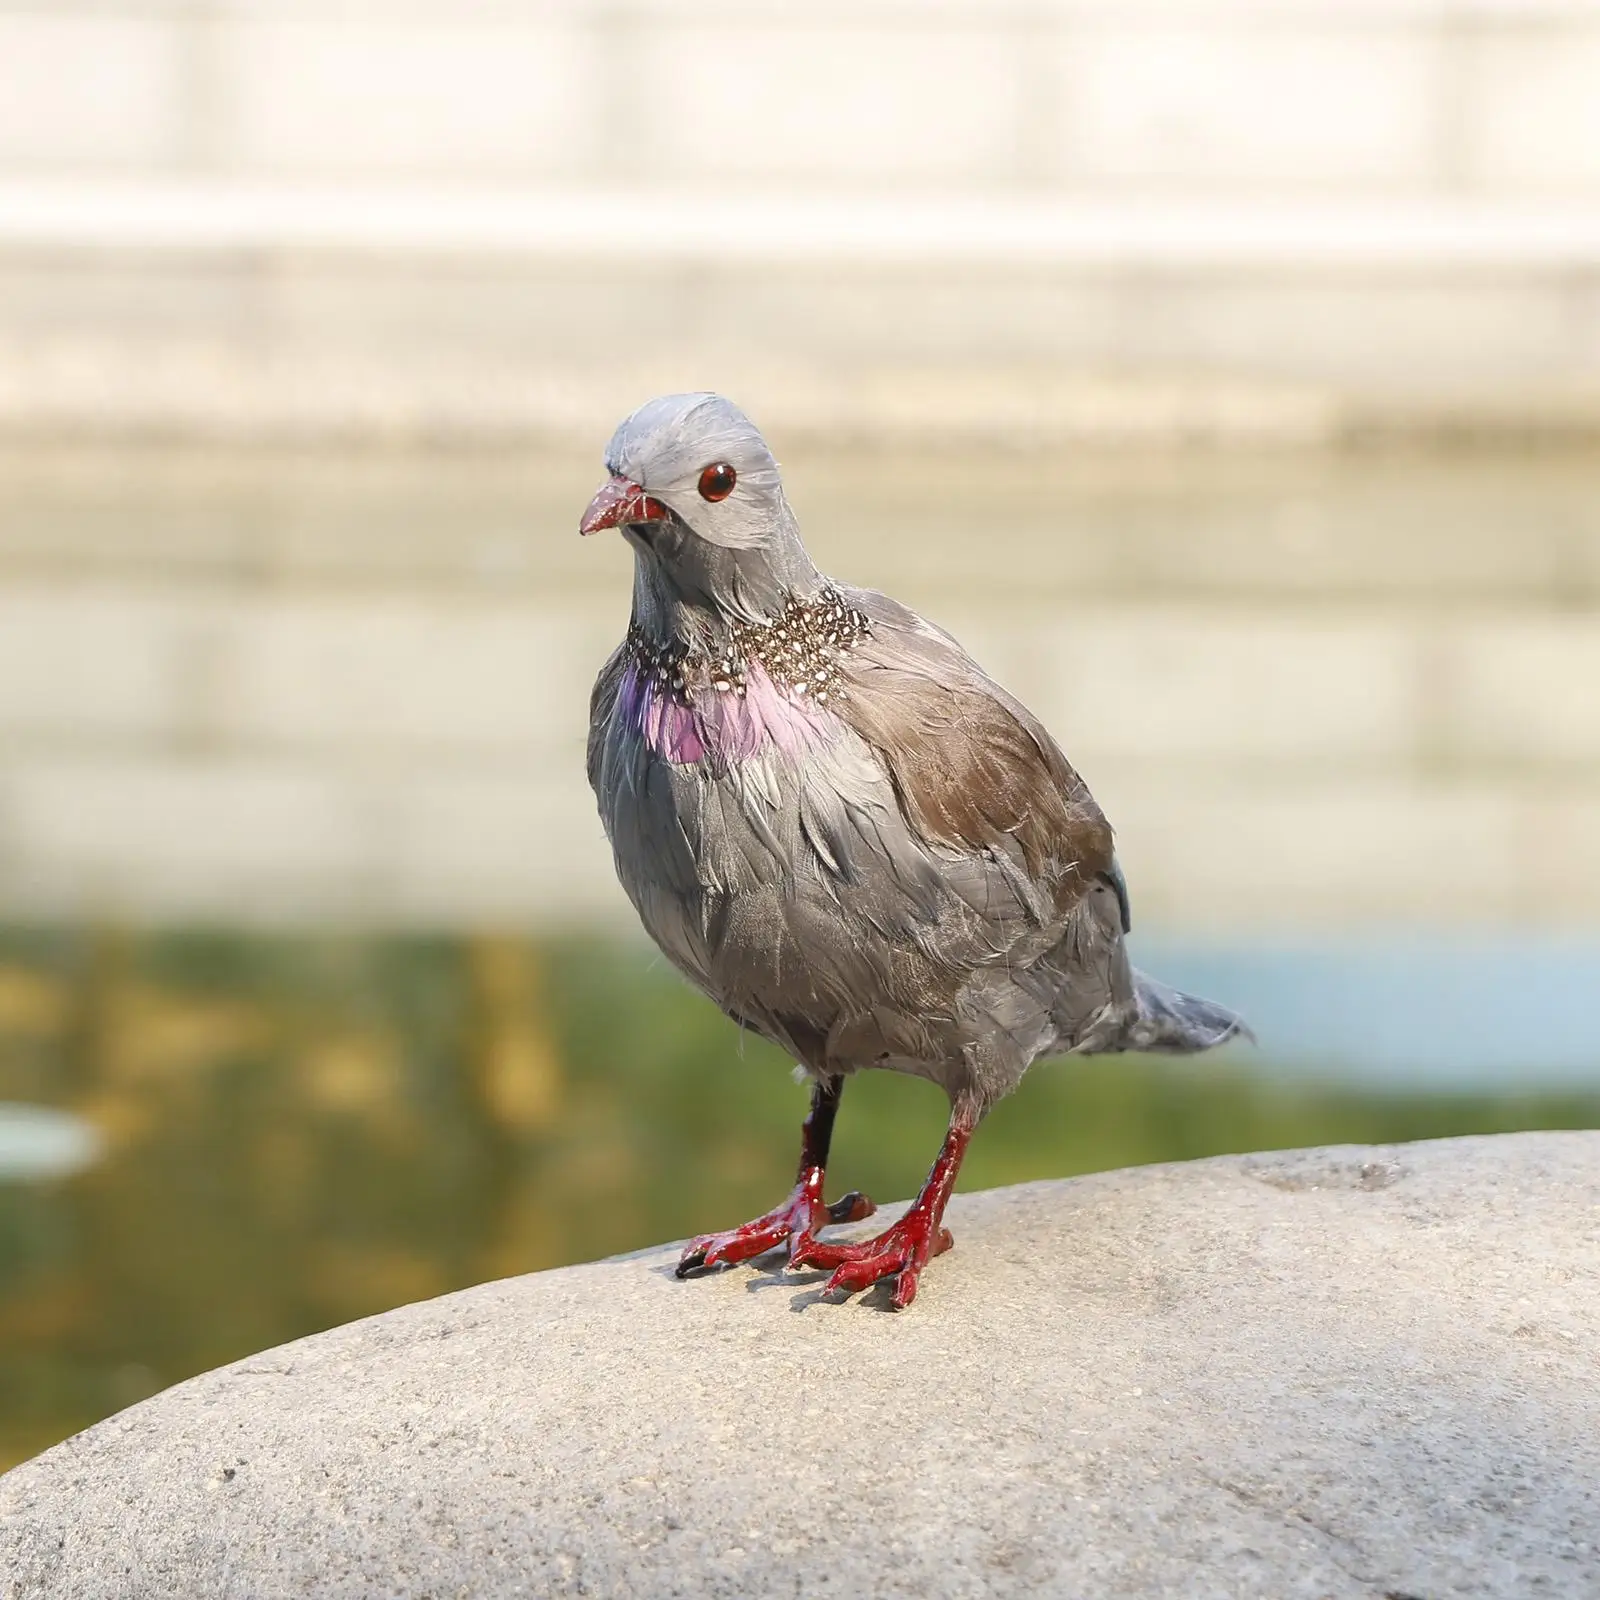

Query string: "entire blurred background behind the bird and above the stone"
[[0, 0, 1600, 1466]]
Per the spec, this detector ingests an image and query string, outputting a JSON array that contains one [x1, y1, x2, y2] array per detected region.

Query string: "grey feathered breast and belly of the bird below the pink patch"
[[598, 713, 1088, 1098]]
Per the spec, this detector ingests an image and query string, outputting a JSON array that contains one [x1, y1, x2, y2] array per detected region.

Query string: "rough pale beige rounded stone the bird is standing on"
[[0, 1133, 1600, 1600]]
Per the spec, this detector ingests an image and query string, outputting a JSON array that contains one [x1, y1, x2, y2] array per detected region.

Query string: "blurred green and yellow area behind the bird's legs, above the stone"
[[0, 930, 1600, 1466]]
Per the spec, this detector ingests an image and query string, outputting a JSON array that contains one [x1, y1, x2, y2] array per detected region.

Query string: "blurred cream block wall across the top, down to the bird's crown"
[[0, 0, 1600, 438]]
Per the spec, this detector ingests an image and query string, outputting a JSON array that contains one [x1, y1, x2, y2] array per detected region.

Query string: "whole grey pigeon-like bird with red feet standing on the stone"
[[579, 392, 1250, 1309]]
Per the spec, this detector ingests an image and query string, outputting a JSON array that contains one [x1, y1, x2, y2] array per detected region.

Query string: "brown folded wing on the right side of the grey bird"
[[837, 590, 1112, 909]]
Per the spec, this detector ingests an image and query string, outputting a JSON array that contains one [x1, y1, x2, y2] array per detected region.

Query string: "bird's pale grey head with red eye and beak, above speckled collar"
[[579, 394, 821, 638]]
